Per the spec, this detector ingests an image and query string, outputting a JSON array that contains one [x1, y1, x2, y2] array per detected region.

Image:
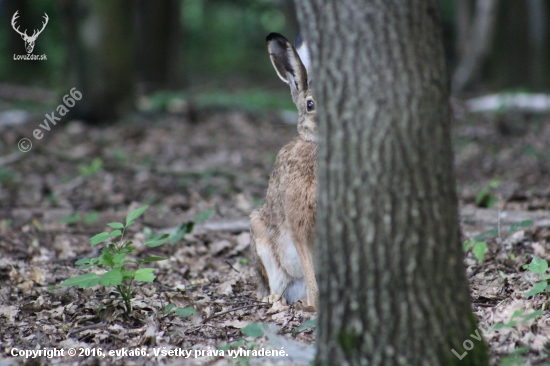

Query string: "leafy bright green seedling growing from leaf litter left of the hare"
[[61, 206, 168, 315]]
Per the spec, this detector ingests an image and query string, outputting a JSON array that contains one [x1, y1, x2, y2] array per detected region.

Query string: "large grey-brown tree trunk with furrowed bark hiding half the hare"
[[296, 0, 488, 366]]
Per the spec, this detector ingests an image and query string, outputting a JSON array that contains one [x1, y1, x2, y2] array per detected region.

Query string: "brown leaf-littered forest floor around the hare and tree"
[[0, 99, 550, 365]]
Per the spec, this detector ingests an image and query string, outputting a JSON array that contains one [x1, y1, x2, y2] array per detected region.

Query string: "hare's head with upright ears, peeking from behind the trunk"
[[266, 33, 317, 141]]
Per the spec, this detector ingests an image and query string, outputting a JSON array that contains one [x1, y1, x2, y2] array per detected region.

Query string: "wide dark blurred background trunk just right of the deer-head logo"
[[61, 0, 134, 122]]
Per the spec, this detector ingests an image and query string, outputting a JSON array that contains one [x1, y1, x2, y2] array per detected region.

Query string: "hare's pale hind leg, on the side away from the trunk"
[[250, 211, 293, 298]]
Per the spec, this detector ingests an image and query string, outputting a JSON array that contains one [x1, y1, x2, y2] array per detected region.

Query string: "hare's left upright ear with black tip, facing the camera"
[[266, 33, 307, 91]]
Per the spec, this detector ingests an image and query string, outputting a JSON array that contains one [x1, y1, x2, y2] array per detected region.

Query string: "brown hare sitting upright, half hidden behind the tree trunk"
[[250, 33, 318, 307]]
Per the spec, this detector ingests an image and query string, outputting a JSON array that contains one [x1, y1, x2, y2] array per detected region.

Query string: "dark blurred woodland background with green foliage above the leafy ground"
[[0, 0, 550, 121]]
